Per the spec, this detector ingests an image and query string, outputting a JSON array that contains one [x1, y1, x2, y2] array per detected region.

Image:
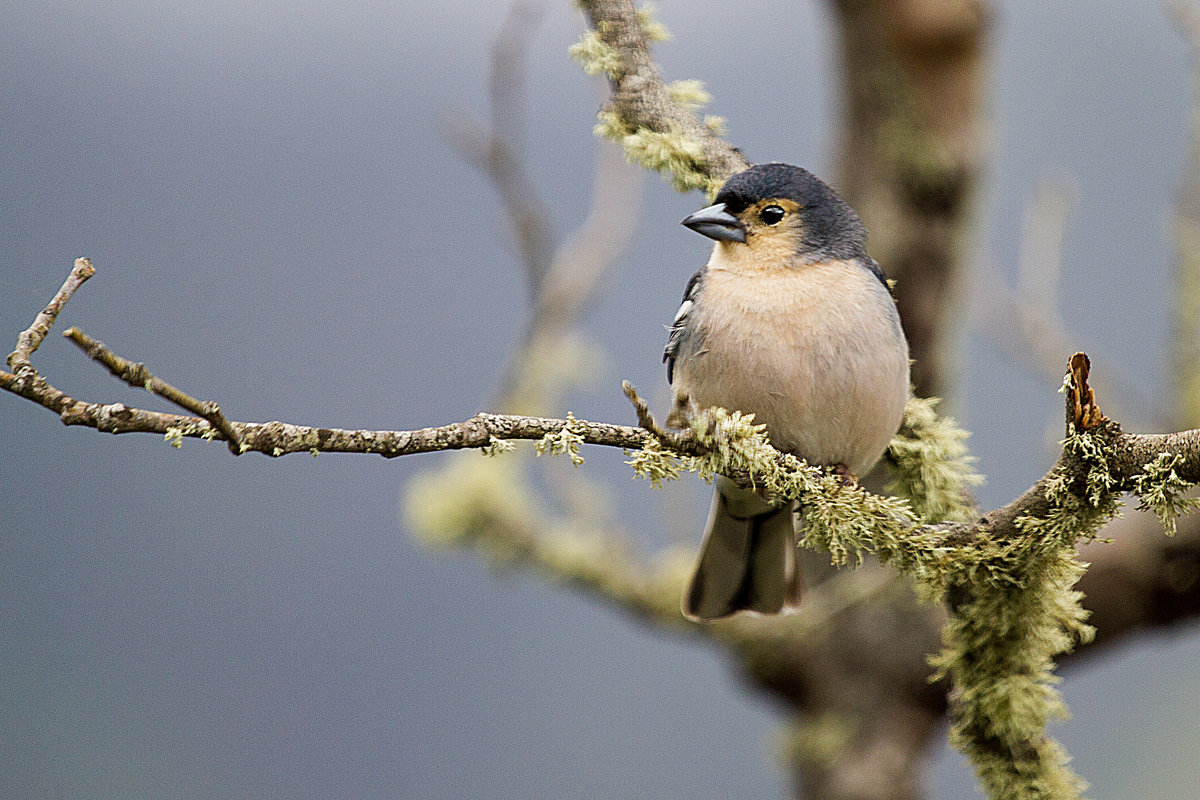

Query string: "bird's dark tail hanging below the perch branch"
[[683, 477, 800, 620]]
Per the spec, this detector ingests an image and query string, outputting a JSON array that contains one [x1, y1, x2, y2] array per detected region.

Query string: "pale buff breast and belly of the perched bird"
[[673, 263, 908, 475]]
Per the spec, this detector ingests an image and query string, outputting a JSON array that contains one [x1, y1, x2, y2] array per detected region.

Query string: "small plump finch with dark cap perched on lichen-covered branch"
[[662, 162, 911, 621]]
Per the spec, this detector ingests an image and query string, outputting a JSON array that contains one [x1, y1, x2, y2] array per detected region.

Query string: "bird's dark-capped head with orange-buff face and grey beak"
[[683, 163, 866, 267]]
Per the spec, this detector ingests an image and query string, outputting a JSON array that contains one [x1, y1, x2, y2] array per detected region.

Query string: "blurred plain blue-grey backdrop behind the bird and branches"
[[0, 0, 1200, 800]]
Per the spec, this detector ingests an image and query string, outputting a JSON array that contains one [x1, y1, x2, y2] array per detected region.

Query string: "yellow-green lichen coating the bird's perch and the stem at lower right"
[[638, 401, 1113, 800]]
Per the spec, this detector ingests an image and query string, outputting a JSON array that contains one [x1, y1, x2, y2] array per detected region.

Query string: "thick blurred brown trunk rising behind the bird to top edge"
[[830, 0, 990, 396]]
